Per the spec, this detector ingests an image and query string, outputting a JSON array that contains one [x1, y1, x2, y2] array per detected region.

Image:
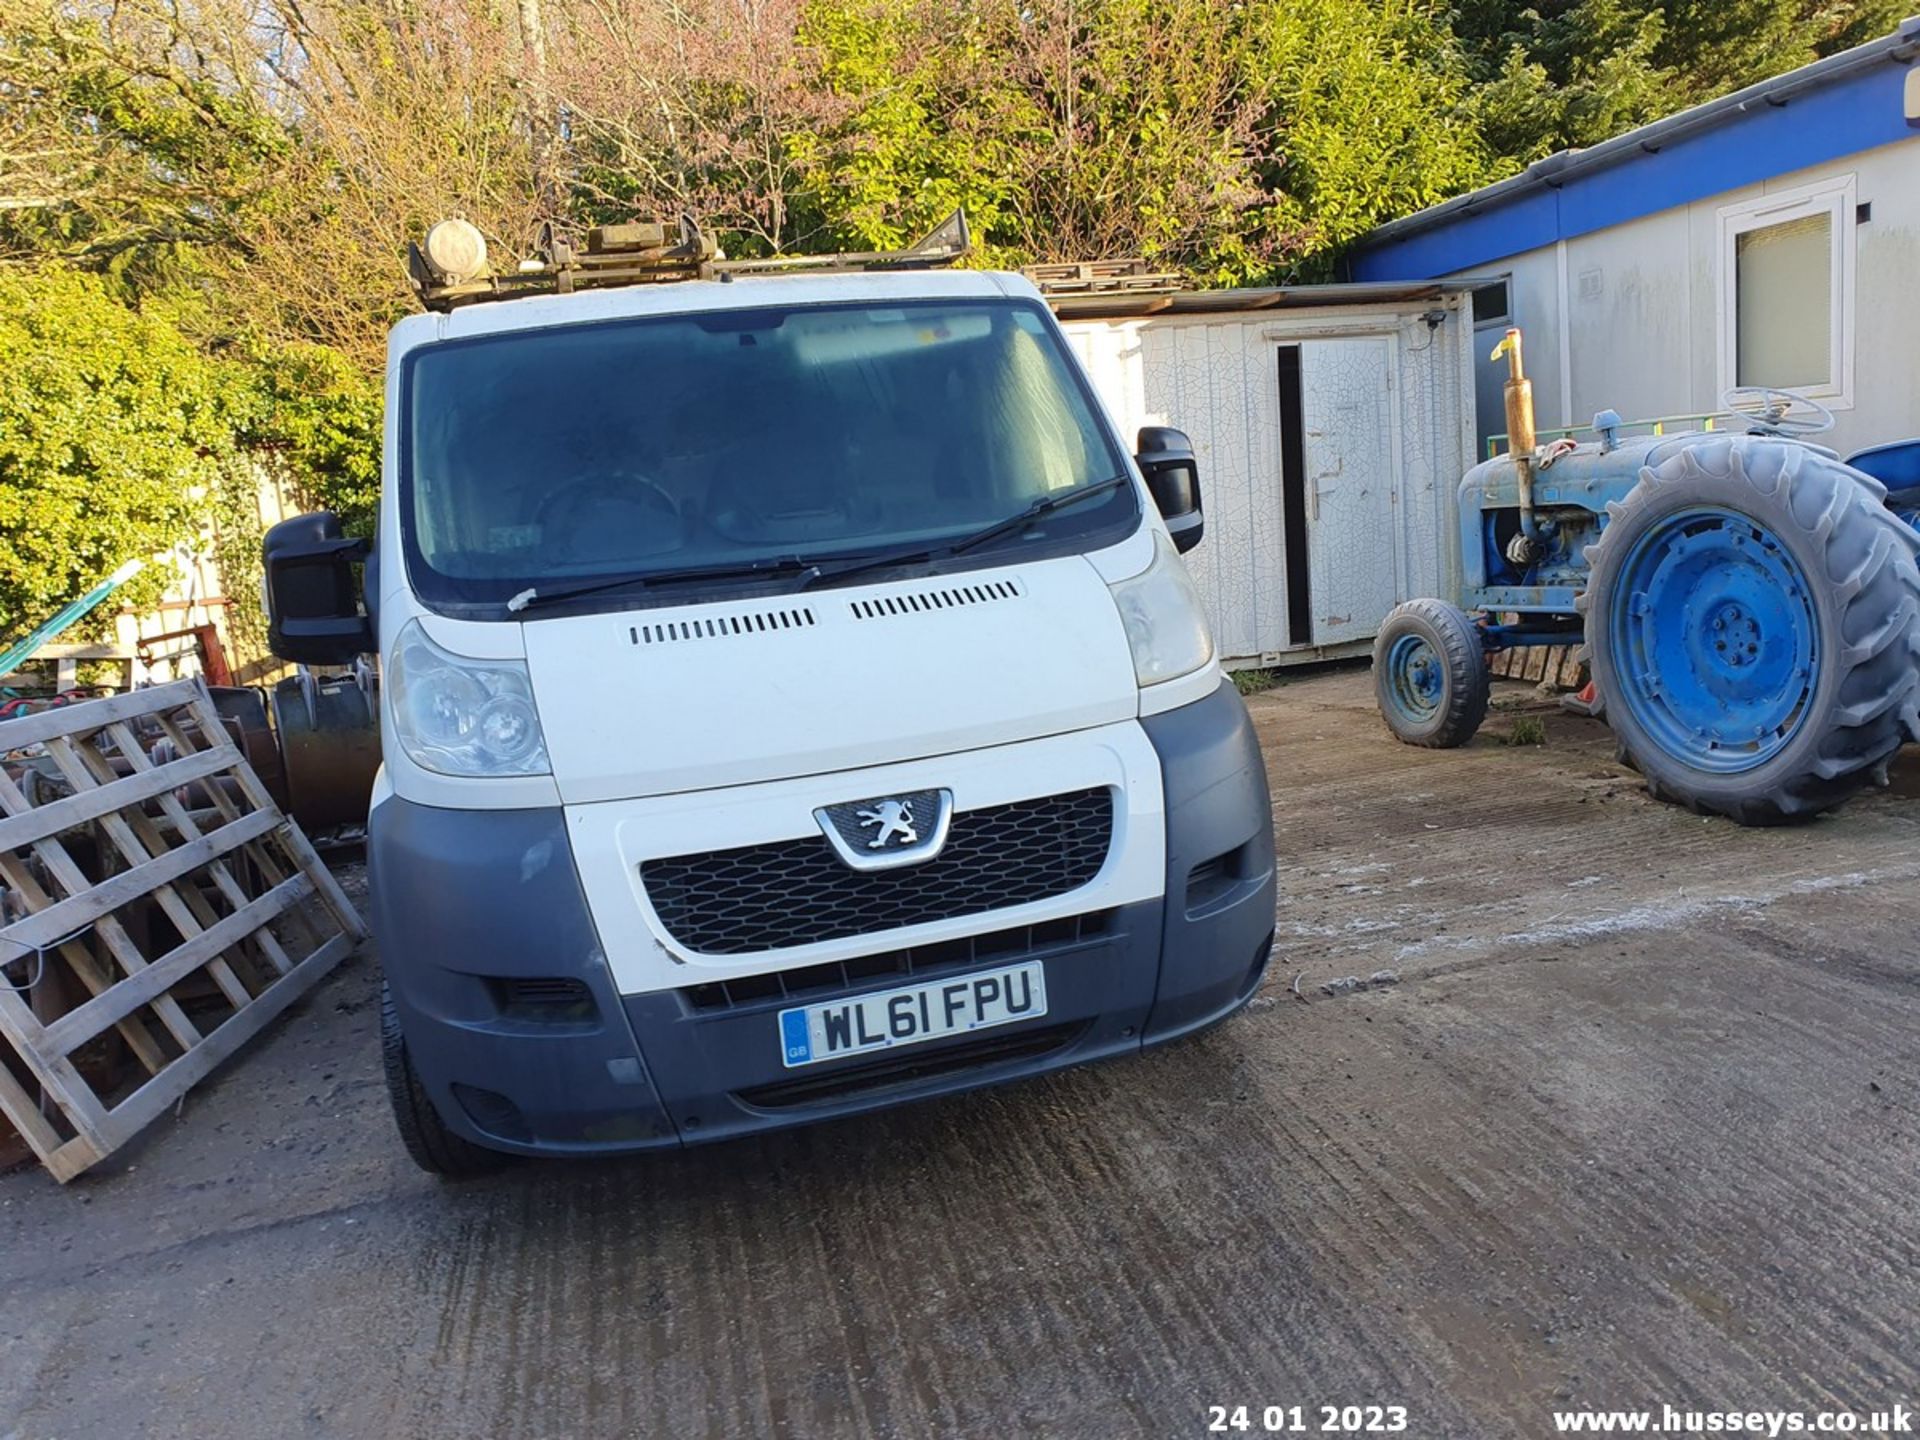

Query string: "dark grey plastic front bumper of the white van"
[[369, 684, 1275, 1154]]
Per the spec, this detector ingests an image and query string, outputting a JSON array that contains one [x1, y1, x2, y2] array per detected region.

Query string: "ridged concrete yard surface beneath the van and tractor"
[[0, 670, 1920, 1440]]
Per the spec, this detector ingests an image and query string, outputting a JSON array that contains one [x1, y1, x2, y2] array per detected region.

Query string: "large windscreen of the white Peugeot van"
[[399, 300, 1139, 607]]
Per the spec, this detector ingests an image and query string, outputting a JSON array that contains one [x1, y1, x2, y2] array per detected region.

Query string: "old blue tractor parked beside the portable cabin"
[[1373, 330, 1920, 826]]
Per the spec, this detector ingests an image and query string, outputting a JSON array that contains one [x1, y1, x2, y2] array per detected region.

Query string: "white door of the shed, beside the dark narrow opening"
[[1300, 336, 1400, 645]]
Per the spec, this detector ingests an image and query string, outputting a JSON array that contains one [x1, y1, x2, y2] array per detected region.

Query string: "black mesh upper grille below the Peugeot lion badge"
[[639, 787, 1114, 954]]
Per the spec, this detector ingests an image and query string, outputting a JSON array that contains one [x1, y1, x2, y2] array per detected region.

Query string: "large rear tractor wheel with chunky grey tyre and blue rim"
[[1578, 436, 1920, 826]]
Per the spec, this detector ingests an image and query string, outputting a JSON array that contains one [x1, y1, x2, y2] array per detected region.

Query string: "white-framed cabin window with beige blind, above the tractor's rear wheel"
[[1718, 175, 1855, 407]]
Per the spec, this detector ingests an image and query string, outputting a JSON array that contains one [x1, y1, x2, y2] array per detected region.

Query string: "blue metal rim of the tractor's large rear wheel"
[[1607, 507, 1820, 774]]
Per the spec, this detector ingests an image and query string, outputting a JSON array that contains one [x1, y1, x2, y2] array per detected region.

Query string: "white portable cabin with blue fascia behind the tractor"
[[1346, 17, 1920, 455]]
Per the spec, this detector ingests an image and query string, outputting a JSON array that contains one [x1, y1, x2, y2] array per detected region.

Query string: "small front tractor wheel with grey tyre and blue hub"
[[1373, 599, 1492, 751]]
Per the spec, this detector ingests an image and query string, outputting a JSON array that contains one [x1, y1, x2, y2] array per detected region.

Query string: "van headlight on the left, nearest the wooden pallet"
[[382, 620, 549, 776]]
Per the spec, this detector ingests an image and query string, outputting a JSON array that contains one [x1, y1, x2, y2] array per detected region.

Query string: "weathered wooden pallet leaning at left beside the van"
[[0, 680, 367, 1181]]
